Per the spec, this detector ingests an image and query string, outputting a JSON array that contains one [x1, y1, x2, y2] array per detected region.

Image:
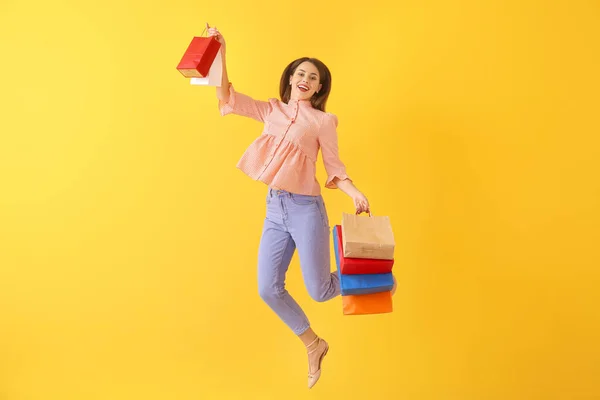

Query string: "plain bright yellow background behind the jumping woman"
[[0, 0, 600, 400]]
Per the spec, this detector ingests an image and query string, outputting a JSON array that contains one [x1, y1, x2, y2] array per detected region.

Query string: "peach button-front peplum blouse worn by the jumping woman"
[[219, 83, 350, 196]]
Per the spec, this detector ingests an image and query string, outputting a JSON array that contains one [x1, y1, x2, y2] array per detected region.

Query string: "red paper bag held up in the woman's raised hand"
[[177, 36, 221, 78]]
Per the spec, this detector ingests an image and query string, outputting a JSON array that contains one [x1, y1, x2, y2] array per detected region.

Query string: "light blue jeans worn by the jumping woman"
[[258, 189, 340, 335]]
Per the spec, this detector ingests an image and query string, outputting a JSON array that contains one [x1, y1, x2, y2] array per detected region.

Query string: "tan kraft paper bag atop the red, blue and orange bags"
[[342, 213, 396, 260]]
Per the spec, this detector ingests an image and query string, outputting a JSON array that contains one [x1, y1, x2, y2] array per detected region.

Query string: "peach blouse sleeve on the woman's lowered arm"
[[319, 113, 352, 189]]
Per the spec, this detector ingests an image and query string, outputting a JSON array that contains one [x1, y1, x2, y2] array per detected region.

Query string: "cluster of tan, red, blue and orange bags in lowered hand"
[[332, 213, 395, 315]]
